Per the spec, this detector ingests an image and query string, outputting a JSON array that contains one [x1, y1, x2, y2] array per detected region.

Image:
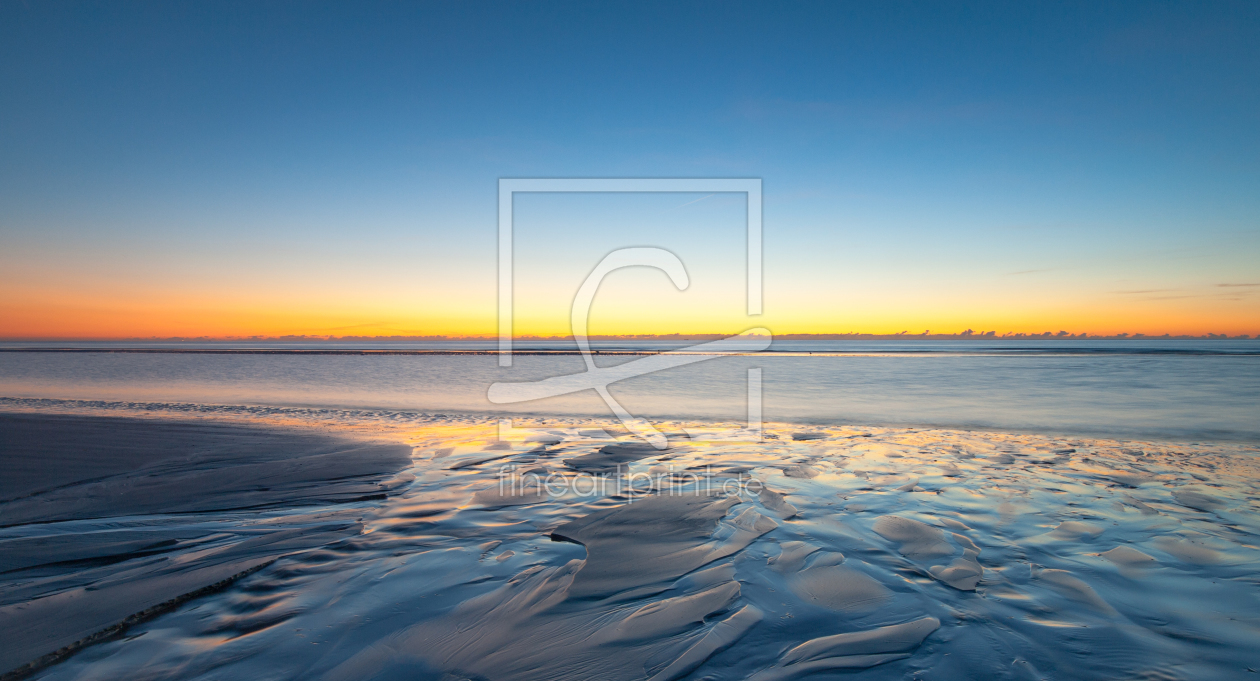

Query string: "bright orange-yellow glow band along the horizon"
[[0, 291, 1260, 341]]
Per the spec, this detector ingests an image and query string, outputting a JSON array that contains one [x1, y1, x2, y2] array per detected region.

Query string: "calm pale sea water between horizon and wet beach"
[[0, 341, 1260, 440]]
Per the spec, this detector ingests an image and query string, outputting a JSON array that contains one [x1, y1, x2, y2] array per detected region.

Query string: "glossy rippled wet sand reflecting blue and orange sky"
[[0, 412, 1260, 680]]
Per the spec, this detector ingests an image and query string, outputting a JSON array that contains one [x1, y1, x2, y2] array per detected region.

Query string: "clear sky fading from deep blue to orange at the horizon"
[[0, 0, 1260, 339]]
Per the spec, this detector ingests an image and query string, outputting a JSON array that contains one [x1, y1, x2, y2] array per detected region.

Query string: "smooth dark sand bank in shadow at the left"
[[0, 414, 411, 672]]
